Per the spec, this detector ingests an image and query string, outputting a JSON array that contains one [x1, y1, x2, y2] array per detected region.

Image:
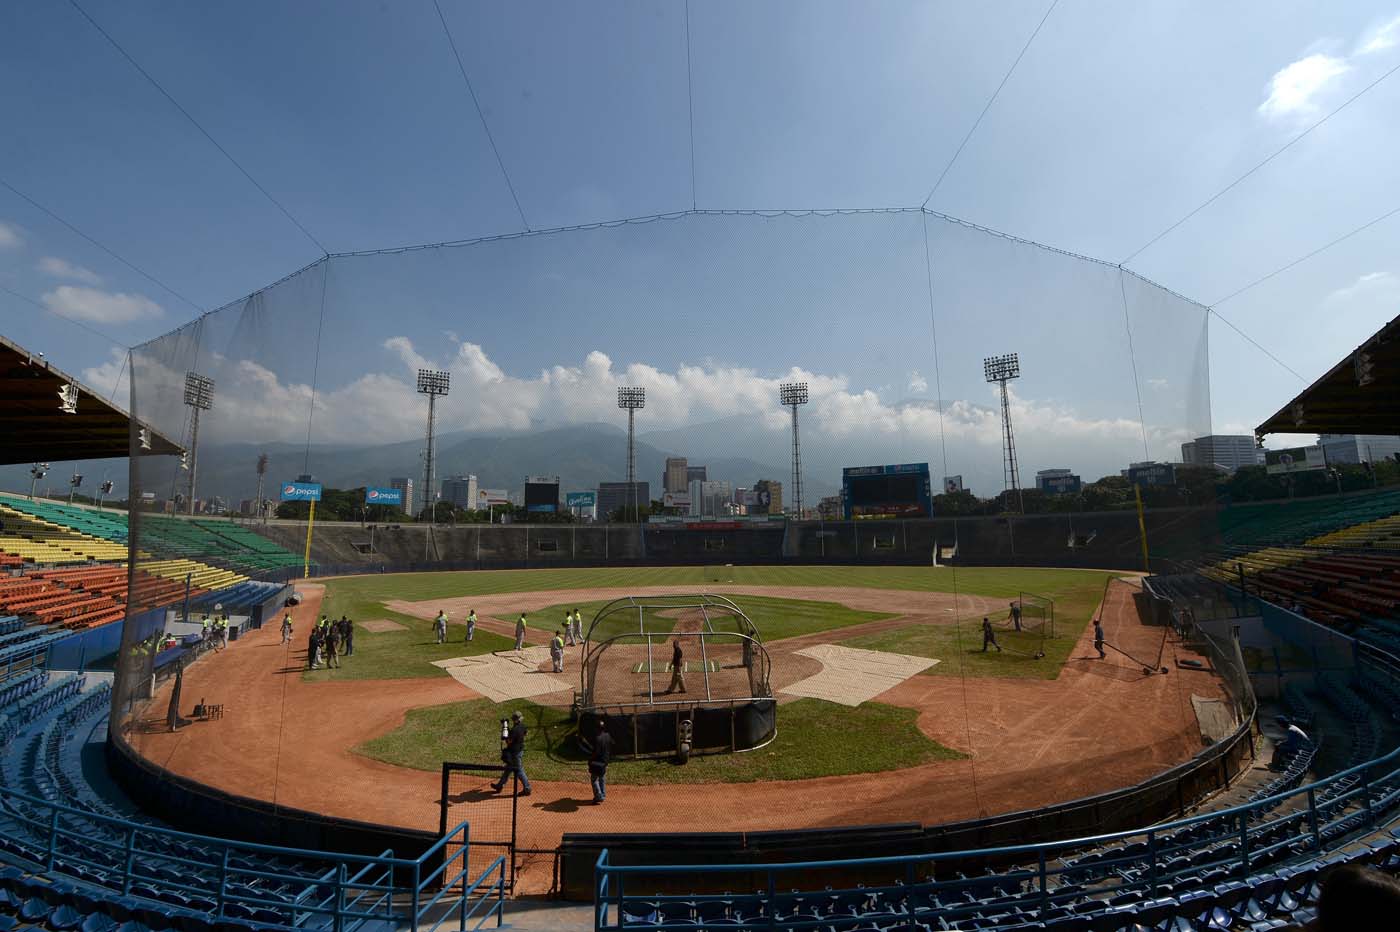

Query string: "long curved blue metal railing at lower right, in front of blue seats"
[[594, 749, 1400, 932]]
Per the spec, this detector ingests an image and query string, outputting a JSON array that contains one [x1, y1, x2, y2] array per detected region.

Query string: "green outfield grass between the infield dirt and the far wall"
[[315, 567, 1117, 680]]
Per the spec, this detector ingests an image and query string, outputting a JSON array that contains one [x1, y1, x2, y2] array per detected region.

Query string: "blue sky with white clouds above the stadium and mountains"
[[0, 0, 1400, 481]]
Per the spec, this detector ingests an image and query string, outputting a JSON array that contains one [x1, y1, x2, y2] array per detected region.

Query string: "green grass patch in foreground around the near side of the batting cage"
[[354, 698, 963, 784]]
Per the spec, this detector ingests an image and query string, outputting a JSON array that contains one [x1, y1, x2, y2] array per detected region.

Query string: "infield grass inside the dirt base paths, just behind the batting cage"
[[535, 593, 895, 644]]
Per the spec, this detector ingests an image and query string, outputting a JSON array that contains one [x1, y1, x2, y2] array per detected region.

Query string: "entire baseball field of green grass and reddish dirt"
[[128, 567, 1224, 890]]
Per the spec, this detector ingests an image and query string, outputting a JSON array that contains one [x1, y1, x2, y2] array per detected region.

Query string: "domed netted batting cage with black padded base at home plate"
[[578, 595, 777, 757]]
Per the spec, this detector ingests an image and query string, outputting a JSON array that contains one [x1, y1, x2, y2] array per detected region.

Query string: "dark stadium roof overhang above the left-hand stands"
[[0, 337, 183, 465]]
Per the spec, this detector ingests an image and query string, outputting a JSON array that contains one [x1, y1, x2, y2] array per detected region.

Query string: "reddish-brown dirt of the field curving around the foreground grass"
[[132, 573, 1225, 890]]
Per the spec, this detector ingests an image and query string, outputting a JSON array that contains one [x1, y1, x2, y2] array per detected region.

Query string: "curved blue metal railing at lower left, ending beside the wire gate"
[[0, 788, 505, 932]]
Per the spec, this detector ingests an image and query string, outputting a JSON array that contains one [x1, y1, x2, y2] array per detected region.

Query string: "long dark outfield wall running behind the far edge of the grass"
[[253, 508, 1218, 574]]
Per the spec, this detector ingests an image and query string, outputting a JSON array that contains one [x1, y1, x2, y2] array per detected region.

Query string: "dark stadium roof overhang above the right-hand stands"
[[1254, 318, 1400, 438]]
